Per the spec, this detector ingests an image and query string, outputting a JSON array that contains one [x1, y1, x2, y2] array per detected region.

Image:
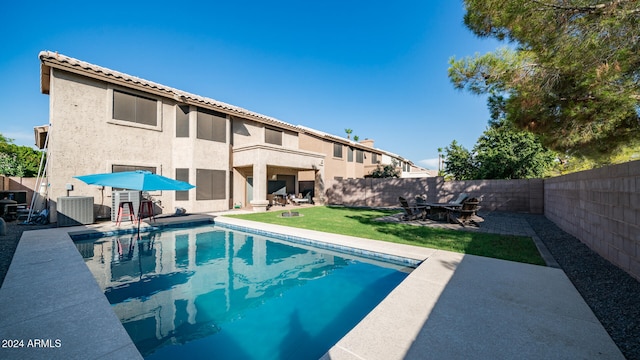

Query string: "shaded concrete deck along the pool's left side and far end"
[[0, 215, 213, 359]]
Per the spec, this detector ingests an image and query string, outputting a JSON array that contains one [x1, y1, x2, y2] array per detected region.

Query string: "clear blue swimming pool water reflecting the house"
[[76, 225, 407, 359]]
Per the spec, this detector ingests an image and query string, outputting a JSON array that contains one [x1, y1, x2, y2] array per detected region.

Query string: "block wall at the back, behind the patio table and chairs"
[[327, 177, 544, 214]]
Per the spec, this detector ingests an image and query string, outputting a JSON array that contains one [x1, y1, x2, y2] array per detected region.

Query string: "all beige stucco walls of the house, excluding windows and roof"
[[42, 59, 420, 221]]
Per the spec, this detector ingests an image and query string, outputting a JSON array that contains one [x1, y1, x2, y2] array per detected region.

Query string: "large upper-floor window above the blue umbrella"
[[113, 90, 158, 126]]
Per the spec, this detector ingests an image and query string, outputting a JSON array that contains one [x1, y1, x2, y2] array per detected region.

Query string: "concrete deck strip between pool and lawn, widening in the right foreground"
[[216, 216, 624, 360]]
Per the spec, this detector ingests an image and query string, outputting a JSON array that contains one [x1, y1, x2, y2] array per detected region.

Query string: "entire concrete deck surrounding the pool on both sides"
[[0, 214, 624, 360]]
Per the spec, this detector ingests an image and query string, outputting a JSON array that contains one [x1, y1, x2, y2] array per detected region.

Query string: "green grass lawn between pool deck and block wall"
[[226, 206, 545, 265]]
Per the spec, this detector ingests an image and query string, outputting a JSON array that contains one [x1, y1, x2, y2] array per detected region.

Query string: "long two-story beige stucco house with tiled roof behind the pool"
[[39, 51, 430, 221]]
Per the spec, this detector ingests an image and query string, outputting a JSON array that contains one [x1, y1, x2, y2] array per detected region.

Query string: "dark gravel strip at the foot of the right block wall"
[[526, 215, 640, 360]]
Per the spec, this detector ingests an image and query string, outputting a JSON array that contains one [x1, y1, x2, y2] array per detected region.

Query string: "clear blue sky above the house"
[[0, 0, 501, 169]]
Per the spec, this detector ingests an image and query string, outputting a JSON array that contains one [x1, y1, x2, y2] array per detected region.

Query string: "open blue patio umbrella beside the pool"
[[74, 170, 195, 191]]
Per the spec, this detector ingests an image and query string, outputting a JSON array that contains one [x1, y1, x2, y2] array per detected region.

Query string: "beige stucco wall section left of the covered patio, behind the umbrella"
[[49, 69, 229, 222]]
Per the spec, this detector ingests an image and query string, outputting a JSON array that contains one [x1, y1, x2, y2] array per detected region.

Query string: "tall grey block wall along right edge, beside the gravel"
[[544, 161, 640, 280]]
